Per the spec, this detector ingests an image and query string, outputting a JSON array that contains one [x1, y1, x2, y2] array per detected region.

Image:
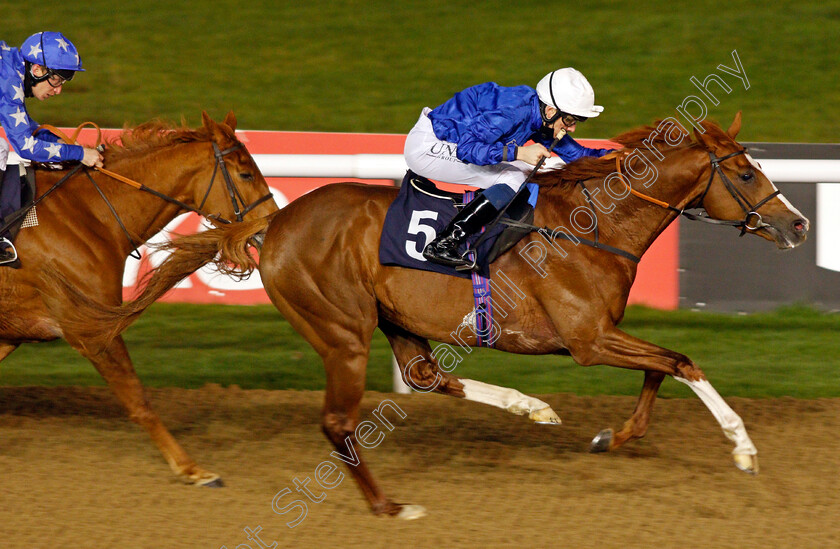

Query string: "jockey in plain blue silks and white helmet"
[[405, 67, 610, 269]]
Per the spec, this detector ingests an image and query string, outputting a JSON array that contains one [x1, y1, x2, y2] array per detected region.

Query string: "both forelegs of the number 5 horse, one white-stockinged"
[[570, 328, 758, 473]]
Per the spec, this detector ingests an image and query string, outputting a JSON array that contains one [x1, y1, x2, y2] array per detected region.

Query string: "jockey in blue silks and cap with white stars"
[[0, 32, 102, 264]]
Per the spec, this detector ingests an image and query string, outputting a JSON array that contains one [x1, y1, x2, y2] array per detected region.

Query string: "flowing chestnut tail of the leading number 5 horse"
[[42, 213, 274, 354]]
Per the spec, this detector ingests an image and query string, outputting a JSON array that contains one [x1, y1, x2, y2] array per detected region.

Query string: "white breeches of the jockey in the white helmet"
[[405, 107, 534, 191]]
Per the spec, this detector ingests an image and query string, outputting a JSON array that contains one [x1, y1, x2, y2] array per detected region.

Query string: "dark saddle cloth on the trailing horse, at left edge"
[[0, 164, 38, 269]]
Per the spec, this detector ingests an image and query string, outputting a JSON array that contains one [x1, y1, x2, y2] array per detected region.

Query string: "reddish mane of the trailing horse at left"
[[108, 118, 236, 160]]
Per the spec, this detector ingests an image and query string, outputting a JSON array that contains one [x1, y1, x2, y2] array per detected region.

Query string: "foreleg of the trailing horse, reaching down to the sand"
[[80, 337, 222, 486]]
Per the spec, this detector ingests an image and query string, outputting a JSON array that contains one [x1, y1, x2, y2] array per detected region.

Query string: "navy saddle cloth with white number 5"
[[379, 170, 537, 278]]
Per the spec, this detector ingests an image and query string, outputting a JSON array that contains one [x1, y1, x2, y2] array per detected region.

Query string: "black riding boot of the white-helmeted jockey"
[[423, 194, 499, 270]]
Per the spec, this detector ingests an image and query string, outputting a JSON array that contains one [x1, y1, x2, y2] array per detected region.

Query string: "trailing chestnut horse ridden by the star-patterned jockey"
[[0, 112, 277, 484]]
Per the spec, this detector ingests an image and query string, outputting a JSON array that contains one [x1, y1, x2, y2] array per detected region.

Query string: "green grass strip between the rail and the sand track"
[[0, 304, 840, 398]]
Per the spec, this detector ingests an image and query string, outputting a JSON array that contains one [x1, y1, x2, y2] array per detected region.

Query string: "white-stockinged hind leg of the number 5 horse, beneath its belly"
[[379, 320, 560, 424]]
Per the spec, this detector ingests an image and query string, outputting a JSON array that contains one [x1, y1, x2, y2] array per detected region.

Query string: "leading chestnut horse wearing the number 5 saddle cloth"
[[57, 113, 809, 518]]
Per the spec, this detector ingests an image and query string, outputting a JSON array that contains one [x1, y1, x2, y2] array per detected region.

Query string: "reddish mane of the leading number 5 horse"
[[534, 120, 704, 189]]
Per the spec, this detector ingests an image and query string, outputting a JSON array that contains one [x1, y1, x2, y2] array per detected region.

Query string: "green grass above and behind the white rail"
[[6, 0, 840, 143]]
